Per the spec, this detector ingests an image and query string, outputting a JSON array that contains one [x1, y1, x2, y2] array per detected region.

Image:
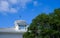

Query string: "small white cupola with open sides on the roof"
[[15, 20, 27, 30]]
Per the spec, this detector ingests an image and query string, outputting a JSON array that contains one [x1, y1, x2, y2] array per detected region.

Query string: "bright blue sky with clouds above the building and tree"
[[0, 0, 60, 28]]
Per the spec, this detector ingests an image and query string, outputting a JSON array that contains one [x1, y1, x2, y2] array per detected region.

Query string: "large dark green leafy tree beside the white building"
[[24, 8, 60, 38]]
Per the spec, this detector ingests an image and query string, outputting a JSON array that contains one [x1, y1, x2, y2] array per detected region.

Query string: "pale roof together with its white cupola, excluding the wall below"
[[0, 20, 27, 33]]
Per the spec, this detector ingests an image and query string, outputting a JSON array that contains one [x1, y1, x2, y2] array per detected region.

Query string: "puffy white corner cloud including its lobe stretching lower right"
[[0, 0, 17, 14]]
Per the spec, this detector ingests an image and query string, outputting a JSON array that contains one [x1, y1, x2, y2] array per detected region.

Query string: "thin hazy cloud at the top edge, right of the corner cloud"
[[8, 0, 32, 8]]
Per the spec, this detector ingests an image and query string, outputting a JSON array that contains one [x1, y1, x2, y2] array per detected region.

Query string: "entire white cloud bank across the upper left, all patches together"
[[0, 0, 32, 13]]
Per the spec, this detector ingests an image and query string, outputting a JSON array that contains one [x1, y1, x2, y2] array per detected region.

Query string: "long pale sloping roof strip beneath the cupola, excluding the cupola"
[[0, 28, 27, 33]]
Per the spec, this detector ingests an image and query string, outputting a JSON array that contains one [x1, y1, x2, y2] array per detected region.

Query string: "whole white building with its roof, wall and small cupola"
[[0, 20, 27, 38]]
